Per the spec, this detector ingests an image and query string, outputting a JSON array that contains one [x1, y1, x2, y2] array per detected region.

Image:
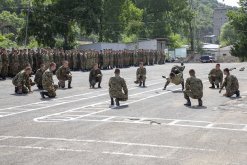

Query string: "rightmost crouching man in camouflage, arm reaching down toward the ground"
[[219, 68, 240, 97]]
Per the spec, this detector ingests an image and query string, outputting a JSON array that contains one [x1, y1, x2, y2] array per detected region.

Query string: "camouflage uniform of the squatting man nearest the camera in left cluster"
[[42, 69, 57, 98]]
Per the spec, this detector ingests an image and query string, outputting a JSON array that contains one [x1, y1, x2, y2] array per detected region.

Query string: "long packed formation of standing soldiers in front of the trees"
[[0, 48, 165, 79]]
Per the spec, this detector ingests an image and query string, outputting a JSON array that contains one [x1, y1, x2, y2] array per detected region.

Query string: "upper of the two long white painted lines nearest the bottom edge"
[[0, 136, 216, 152]]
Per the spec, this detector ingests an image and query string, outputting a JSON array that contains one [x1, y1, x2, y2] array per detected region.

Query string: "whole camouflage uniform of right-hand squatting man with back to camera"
[[184, 76, 203, 100]]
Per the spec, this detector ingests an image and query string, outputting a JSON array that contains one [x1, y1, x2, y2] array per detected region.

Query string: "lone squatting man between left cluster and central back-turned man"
[[89, 64, 102, 88]]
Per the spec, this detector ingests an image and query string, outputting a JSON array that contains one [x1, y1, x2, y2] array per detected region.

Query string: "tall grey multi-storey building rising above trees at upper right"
[[213, 7, 228, 37]]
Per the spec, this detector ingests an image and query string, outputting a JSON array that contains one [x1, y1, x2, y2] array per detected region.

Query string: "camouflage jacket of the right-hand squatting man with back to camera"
[[185, 76, 203, 98]]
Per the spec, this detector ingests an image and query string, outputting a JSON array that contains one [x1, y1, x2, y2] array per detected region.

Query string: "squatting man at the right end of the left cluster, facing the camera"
[[56, 61, 72, 89]]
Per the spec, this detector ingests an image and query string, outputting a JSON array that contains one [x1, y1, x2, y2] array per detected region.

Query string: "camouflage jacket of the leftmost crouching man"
[[12, 70, 30, 87]]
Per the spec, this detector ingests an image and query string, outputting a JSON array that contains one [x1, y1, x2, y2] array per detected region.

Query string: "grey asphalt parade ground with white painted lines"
[[0, 63, 247, 165]]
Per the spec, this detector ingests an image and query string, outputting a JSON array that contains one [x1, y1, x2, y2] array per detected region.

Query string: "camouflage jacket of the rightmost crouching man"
[[221, 75, 239, 93]]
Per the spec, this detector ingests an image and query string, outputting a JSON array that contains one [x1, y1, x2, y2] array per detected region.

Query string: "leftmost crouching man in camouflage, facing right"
[[12, 67, 32, 94]]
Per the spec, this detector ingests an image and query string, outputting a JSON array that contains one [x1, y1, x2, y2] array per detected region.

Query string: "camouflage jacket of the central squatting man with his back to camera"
[[109, 76, 128, 98]]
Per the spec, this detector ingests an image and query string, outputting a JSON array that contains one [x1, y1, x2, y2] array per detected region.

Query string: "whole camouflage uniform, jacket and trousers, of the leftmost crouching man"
[[12, 70, 31, 94]]
